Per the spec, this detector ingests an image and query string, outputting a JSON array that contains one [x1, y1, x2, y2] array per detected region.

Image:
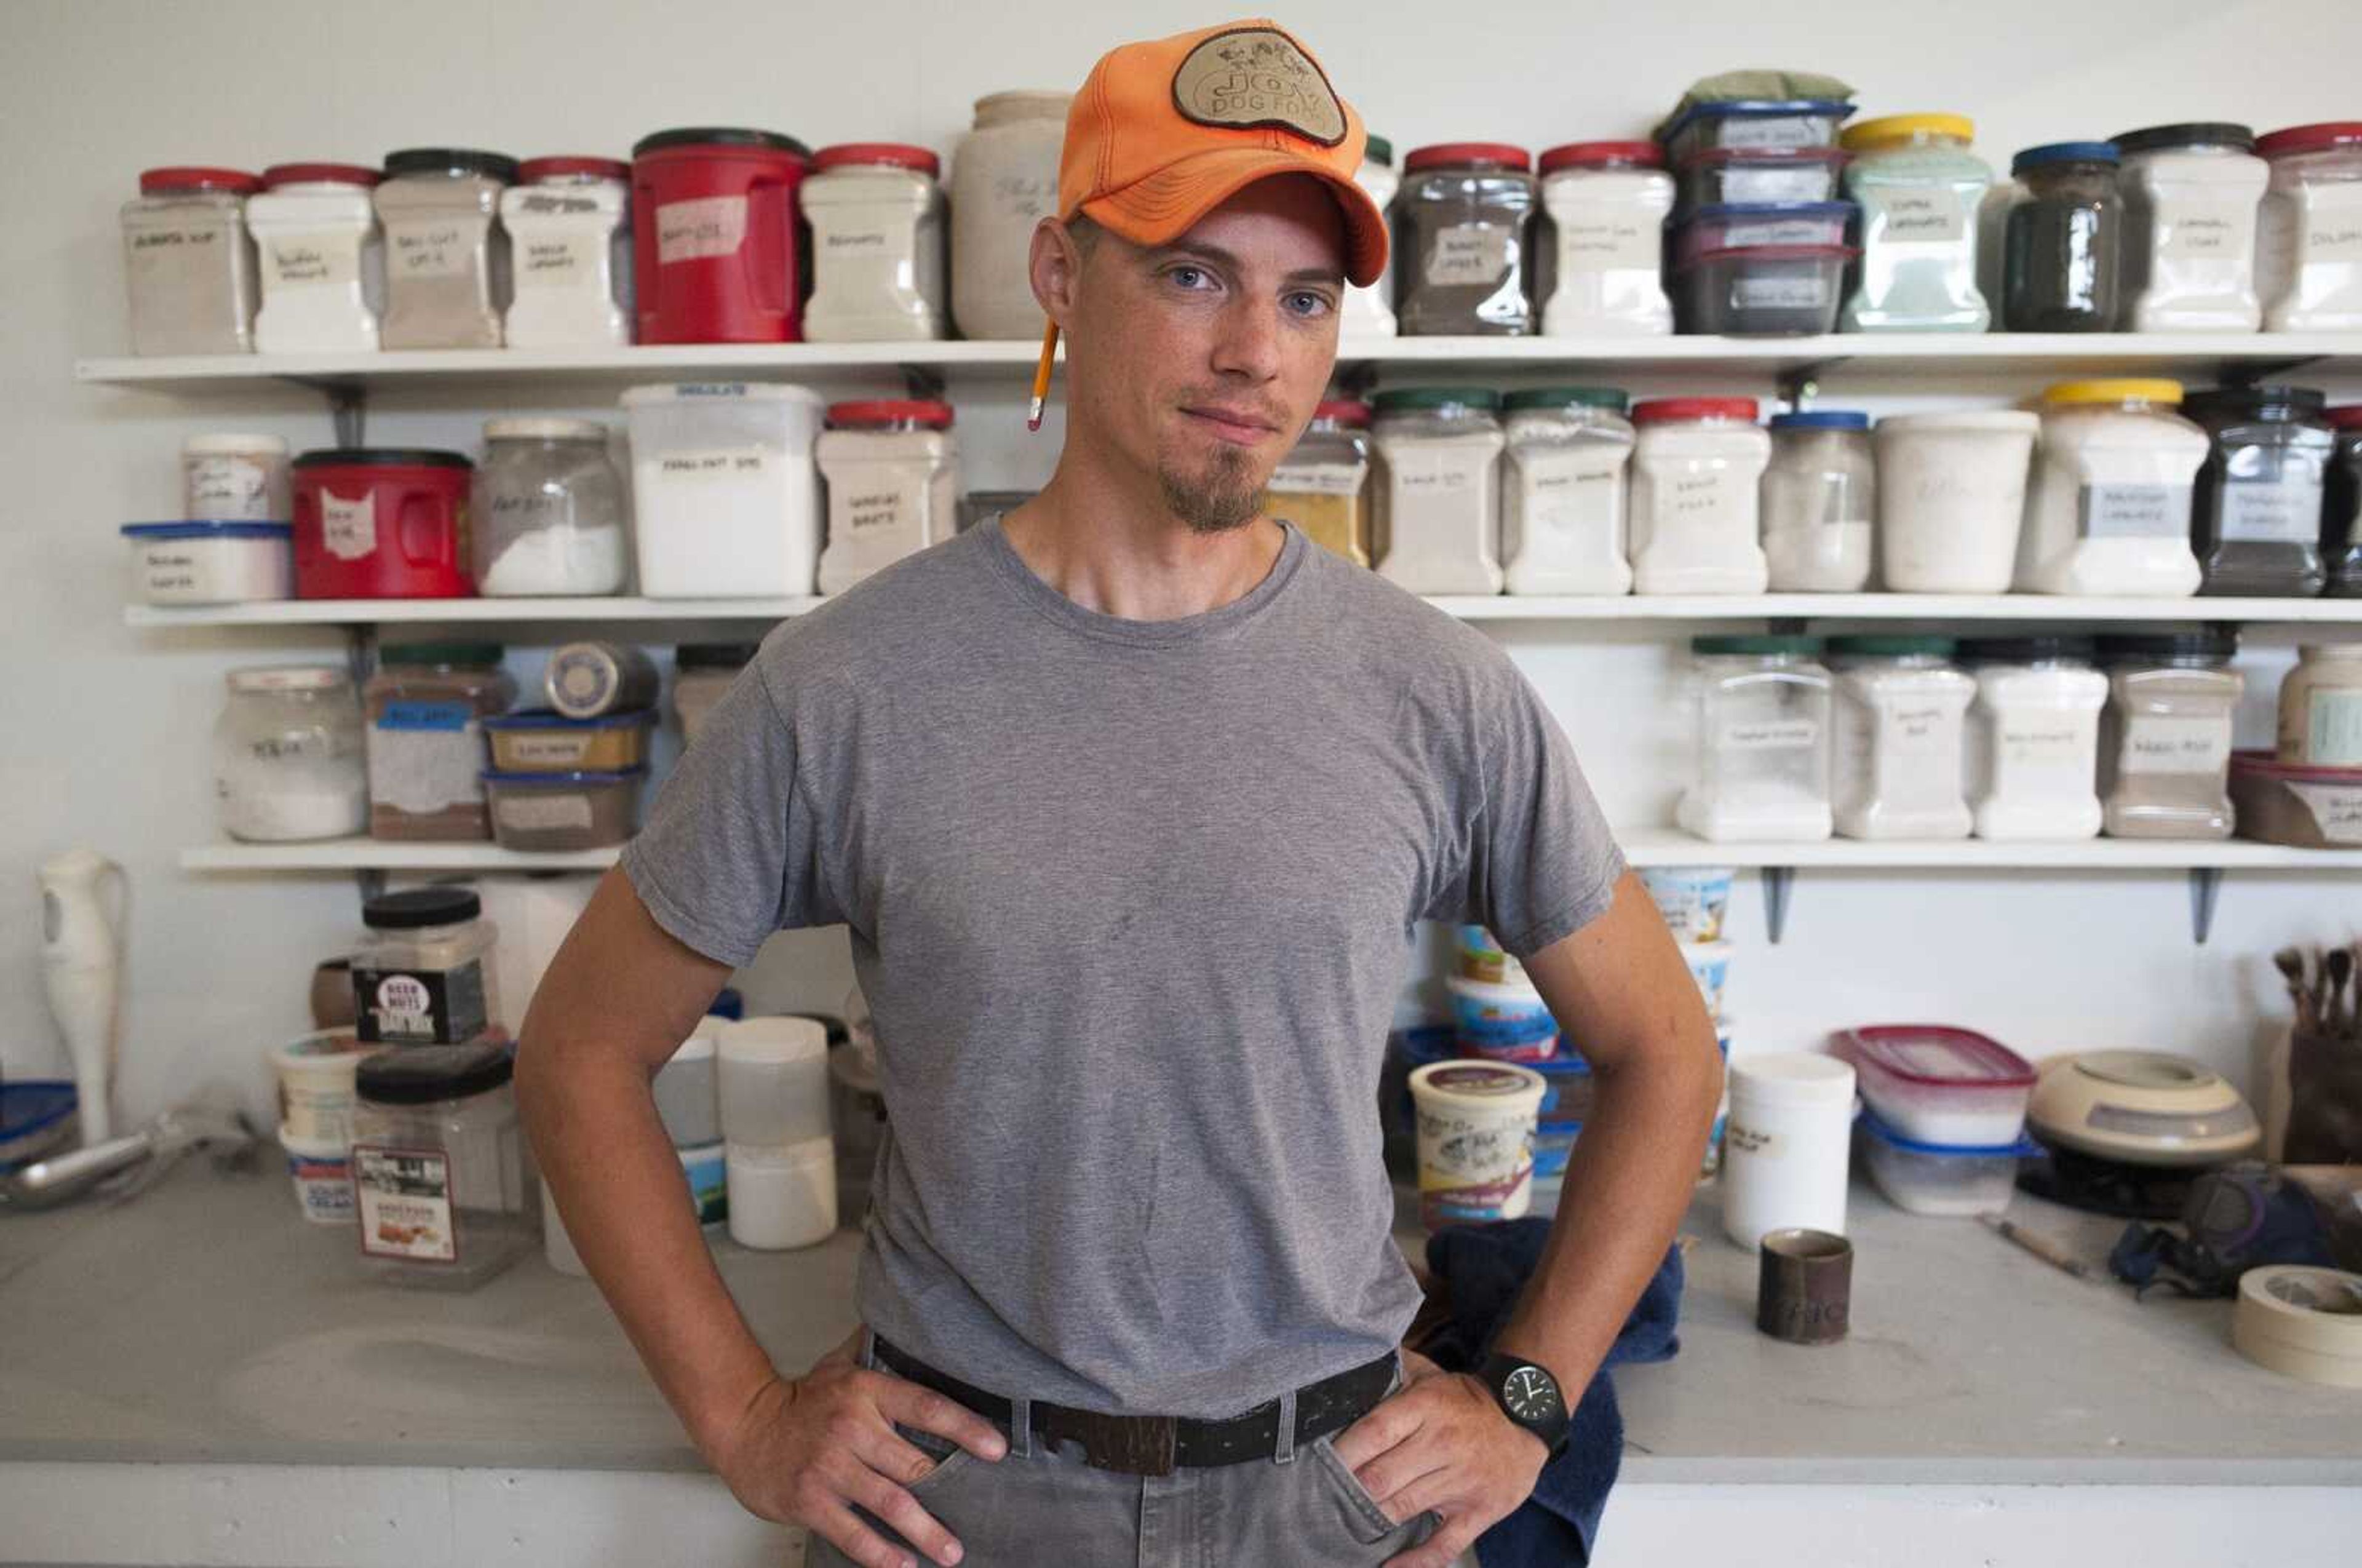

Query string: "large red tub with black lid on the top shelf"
[[630, 125, 810, 343]]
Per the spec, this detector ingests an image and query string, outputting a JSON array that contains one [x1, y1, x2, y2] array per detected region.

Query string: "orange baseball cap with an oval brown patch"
[[1058, 19, 1386, 288]]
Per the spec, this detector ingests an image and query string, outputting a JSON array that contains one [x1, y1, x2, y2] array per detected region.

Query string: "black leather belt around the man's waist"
[[872, 1339, 1394, 1476]]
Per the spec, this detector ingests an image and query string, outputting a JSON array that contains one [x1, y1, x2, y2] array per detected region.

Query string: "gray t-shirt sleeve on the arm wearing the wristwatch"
[[1426, 666, 1625, 959]]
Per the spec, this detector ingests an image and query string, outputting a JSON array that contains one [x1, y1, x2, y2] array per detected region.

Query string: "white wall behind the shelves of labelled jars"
[[0, 0, 2362, 1133]]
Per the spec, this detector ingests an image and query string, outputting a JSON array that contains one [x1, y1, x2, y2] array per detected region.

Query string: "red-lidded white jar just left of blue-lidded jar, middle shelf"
[[1630, 397, 1772, 593]]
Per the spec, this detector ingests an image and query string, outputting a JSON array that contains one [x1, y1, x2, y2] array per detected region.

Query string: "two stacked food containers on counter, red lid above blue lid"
[[1835, 1025, 2036, 1216]]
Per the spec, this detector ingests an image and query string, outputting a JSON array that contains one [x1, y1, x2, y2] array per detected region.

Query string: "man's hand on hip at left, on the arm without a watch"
[[706, 1332, 1009, 1568]]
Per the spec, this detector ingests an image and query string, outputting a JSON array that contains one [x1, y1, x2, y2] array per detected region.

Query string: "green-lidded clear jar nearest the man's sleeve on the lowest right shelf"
[[1677, 635, 1831, 843]]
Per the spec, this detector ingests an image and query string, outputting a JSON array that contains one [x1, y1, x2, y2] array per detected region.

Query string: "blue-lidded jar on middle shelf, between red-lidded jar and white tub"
[[1762, 408, 1878, 593]]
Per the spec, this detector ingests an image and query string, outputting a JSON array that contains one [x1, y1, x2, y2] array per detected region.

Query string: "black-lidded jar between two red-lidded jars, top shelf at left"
[[376, 146, 517, 349]]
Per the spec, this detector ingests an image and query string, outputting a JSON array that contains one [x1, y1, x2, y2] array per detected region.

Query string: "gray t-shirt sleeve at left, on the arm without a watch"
[[624, 659, 846, 966]]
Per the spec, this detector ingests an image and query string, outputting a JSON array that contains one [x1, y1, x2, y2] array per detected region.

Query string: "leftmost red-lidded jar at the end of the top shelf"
[[123, 168, 262, 354]]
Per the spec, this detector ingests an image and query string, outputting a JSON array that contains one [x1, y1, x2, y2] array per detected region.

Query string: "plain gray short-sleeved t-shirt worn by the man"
[[624, 520, 1623, 1417]]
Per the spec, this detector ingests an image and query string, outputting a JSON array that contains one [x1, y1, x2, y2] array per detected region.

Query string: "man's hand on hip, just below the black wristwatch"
[[1335, 1351, 1549, 1568]]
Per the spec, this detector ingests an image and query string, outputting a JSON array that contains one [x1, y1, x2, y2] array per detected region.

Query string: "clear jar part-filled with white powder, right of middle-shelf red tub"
[[467, 418, 628, 597]]
